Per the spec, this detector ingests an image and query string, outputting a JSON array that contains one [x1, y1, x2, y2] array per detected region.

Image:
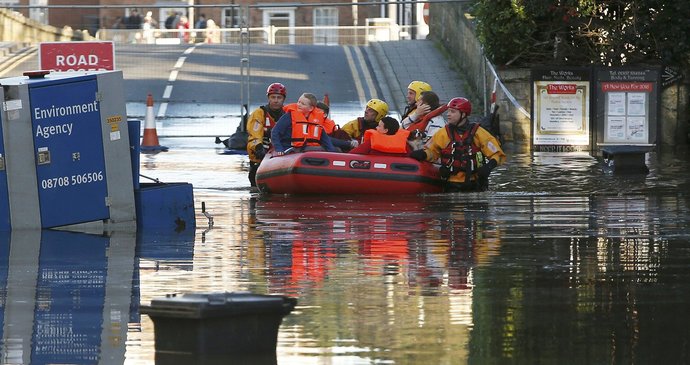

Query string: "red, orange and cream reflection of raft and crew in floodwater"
[[255, 197, 495, 364]]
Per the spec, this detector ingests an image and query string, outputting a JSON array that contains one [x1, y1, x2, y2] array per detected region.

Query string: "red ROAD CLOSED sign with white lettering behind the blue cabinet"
[[38, 42, 115, 71]]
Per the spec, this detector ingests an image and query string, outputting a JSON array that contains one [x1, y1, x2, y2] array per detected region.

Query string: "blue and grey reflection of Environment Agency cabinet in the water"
[[0, 231, 135, 364]]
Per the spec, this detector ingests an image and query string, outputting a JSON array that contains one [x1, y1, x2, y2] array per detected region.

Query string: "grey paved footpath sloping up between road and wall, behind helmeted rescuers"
[[367, 39, 468, 113]]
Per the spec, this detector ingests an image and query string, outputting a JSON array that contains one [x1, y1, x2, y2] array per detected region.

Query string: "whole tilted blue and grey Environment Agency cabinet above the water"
[[0, 71, 136, 230]]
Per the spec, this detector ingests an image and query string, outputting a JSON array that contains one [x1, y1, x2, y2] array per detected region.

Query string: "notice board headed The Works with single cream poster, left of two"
[[532, 67, 591, 152]]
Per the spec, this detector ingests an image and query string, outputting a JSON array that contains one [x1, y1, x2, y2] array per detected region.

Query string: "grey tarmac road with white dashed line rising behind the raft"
[[0, 44, 385, 119]]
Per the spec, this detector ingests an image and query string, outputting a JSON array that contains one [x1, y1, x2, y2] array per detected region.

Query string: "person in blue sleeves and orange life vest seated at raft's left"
[[271, 93, 335, 156]]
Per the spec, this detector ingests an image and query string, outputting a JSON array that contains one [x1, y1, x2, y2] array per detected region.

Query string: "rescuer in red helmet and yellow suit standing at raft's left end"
[[247, 82, 287, 186]]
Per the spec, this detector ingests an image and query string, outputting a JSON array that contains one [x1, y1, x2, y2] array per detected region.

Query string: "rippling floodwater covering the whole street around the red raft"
[[0, 132, 690, 365]]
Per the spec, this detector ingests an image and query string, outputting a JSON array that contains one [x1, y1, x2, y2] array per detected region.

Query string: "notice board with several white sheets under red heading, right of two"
[[596, 68, 659, 145]]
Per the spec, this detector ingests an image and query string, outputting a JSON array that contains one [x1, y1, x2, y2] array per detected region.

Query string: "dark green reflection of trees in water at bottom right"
[[470, 196, 690, 364]]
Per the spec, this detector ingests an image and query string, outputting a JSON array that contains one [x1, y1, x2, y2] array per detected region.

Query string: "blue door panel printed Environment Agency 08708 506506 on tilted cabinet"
[[29, 76, 109, 227]]
